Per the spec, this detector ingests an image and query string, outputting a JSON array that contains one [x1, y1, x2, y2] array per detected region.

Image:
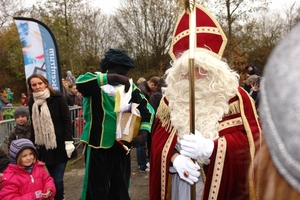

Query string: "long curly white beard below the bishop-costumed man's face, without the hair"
[[166, 79, 229, 139]]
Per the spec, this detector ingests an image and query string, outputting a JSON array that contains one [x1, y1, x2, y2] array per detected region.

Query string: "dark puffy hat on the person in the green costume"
[[104, 49, 134, 68]]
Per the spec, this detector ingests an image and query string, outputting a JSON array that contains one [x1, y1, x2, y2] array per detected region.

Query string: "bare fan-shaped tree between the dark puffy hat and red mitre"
[[114, 0, 183, 70]]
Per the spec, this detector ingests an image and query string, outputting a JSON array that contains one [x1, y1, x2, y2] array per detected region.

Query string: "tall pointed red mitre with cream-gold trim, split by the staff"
[[169, 4, 227, 60]]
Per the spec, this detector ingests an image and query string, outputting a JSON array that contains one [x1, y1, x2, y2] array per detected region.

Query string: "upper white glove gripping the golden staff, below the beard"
[[180, 131, 214, 159]]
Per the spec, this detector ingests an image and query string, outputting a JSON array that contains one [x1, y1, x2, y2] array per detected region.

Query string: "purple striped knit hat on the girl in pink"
[[9, 138, 38, 164]]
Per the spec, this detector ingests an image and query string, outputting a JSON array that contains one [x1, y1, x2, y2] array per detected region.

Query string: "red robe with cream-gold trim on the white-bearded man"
[[149, 88, 261, 200]]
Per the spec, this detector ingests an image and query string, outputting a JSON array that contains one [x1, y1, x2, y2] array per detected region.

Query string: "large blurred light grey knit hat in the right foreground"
[[259, 23, 300, 193]]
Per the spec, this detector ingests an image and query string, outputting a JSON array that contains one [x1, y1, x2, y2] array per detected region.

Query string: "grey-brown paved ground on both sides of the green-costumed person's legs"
[[64, 149, 149, 200]]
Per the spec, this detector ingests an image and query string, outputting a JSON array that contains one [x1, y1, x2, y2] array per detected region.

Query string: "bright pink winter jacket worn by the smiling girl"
[[0, 161, 56, 200]]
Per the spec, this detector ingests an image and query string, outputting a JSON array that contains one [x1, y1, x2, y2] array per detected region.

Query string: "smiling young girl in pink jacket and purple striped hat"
[[0, 139, 56, 200]]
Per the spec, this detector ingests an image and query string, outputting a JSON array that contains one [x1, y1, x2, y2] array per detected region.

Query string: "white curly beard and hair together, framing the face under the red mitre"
[[164, 52, 238, 140]]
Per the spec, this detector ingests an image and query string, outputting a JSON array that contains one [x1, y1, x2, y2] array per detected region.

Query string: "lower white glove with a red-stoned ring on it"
[[173, 155, 200, 185]]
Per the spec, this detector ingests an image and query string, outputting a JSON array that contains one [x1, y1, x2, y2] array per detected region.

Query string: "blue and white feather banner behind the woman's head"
[[14, 17, 62, 91]]
